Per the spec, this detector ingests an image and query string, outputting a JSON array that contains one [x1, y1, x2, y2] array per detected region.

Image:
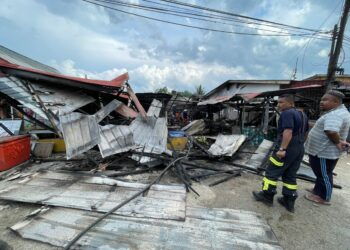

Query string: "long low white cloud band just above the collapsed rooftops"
[[54, 60, 252, 92]]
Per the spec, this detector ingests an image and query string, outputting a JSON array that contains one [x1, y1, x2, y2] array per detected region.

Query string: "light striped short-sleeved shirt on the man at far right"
[[305, 104, 350, 159]]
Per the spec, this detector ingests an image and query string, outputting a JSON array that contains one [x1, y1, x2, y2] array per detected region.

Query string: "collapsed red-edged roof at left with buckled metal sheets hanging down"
[[0, 47, 171, 159]]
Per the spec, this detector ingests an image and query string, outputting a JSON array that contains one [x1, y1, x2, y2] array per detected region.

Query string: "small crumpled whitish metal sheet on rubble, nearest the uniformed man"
[[209, 134, 246, 156]]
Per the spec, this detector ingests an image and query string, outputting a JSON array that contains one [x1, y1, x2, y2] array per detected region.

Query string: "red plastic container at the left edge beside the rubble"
[[0, 135, 30, 171]]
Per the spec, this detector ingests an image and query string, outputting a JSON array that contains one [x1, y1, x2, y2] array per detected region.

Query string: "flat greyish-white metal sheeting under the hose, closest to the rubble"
[[0, 172, 186, 220]]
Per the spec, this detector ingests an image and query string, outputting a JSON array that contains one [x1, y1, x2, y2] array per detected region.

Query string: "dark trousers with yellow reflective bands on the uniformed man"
[[263, 137, 304, 197]]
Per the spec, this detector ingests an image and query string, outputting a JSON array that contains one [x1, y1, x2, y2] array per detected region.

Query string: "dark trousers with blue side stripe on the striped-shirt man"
[[309, 155, 338, 201]]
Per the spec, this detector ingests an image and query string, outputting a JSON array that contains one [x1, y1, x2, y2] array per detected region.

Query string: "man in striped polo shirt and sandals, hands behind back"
[[305, 90, 350, 205]]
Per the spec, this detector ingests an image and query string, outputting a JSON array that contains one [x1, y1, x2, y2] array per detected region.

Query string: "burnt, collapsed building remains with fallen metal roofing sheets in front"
[[0, 47, 348, 249]]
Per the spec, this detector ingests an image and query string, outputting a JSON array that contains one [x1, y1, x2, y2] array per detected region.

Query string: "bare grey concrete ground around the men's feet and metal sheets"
[[0, 156, 350, 250]]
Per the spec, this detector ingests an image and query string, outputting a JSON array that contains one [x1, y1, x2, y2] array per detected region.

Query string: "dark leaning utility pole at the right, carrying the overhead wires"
[[326, 0, 350, 90]]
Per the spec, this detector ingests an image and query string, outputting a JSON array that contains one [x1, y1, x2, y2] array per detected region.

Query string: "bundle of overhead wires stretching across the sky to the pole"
[[82, 0, 332, 40]]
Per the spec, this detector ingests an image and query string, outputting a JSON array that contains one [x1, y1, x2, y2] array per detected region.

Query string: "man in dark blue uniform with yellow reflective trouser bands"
[[253, 95, 309, 212]]
